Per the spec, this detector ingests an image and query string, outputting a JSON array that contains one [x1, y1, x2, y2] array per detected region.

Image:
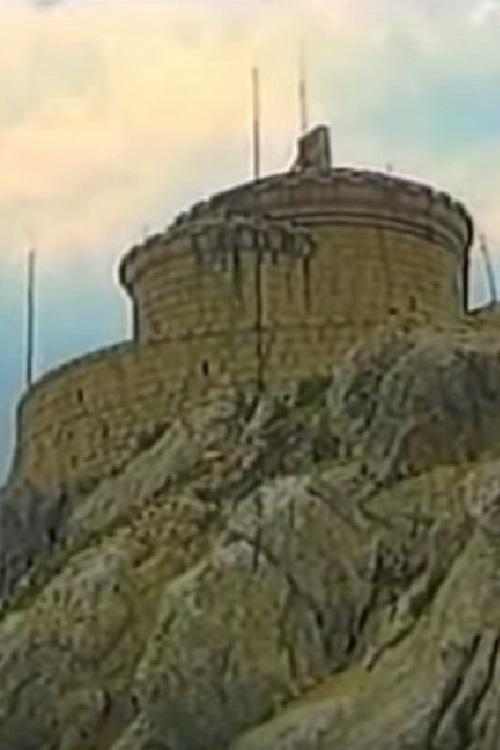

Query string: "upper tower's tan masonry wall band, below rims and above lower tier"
[[124, 213, 463, 348]]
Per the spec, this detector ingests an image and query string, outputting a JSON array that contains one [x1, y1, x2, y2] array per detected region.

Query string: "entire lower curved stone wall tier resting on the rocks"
[[10, 320, 373, 492]]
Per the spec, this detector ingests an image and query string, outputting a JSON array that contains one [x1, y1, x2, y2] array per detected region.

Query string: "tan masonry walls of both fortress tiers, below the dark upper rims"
[[7, 228, 466, 494]]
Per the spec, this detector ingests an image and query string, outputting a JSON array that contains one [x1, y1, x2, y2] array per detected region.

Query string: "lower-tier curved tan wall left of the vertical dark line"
[[11, 335, 262, 489]]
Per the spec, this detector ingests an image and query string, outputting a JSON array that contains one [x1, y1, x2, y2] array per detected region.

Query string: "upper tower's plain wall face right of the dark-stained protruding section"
[[298, 227, 461, 326]]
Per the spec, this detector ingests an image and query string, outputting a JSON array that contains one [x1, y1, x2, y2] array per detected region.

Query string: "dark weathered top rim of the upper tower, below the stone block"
[[188, 168, 473, 262]]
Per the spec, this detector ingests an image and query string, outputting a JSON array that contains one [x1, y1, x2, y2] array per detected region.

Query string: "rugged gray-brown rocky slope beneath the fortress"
[[0, 331, 500, 750]]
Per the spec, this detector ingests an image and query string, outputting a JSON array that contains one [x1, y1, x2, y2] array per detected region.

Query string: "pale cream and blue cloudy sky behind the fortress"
[[0, 0, 500, 479]]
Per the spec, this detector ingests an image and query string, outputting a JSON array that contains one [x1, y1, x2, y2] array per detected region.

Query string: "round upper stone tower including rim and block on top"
[[120, 127, 472, 356]]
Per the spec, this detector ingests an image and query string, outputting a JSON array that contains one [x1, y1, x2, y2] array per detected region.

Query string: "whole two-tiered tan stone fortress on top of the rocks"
[[6, 127, 476, 490]]
